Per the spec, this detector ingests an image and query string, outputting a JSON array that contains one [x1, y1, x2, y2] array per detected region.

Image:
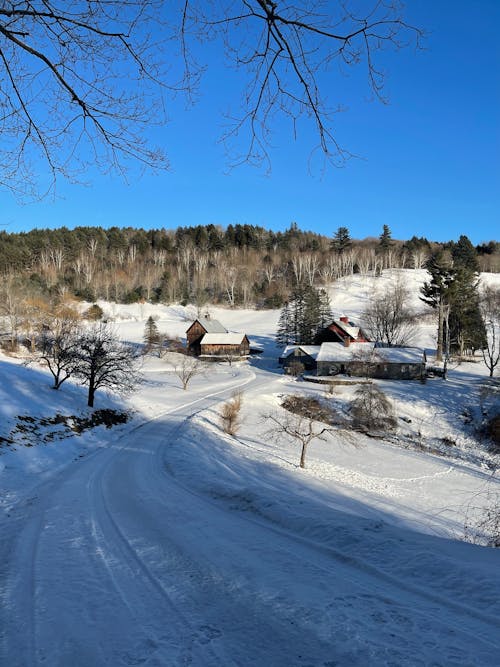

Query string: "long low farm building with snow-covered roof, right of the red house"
[[317, 342, 426, 380]]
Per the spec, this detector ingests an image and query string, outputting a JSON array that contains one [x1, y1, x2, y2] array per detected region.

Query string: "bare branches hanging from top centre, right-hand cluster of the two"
[[181, 0, 422, 170]]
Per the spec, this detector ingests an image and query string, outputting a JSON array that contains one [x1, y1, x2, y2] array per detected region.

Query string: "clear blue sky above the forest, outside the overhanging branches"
[[0, 0, 500, 244]]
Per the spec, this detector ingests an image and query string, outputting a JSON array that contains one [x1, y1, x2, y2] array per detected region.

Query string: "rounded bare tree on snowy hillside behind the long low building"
[[362, 283, 415, 345]]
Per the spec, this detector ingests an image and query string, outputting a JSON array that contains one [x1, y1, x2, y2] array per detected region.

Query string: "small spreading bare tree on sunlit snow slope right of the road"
[[263, 396, 333, 468]]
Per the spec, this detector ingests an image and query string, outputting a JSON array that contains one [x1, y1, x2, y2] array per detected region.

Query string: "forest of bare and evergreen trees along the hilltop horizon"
[[0, 223, 500, 308]]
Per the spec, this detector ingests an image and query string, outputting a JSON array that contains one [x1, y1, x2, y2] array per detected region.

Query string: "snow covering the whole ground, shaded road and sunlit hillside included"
[[0, 271, 500, 667]]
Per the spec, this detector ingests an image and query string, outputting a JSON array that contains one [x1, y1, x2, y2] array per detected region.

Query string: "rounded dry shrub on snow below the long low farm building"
[[351, 384, 397, 431]]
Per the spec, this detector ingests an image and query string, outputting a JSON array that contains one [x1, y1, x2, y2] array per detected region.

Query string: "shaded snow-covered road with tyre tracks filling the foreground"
[[0, 368, 500, 667]]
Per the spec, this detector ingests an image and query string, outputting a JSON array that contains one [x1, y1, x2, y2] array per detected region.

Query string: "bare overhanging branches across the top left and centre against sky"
[[0, 0, 422, 197]]
